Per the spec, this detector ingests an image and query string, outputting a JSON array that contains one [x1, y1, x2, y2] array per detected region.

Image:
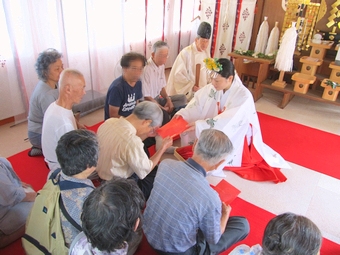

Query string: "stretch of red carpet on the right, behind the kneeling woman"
[[258, 112, 340, 179]]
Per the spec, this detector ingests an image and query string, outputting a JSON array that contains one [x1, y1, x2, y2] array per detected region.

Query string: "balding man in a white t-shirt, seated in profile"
[[42, 69, 86, 171]]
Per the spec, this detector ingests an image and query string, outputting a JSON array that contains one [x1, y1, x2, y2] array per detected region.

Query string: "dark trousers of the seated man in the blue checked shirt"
[[156, 216, 250, 255]]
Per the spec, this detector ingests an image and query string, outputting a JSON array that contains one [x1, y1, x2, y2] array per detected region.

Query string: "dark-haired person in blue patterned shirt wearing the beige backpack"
[[28, 129, 99, 247]]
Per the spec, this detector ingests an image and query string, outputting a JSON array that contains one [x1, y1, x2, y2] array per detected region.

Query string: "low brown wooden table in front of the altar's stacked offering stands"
[[260, 79, 340, 109]]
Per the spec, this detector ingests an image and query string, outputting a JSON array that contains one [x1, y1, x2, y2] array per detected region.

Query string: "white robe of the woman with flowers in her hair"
[[177, 75, 290, 175]]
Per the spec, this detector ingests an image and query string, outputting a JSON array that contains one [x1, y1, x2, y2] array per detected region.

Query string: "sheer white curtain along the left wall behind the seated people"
[[0, 0, 198, 120]]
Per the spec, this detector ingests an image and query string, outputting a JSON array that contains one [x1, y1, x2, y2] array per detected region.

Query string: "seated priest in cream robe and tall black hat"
[[166, 22, 211, 101]]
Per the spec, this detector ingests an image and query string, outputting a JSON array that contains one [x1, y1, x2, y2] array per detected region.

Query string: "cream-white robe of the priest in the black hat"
[[166, 42, 210, 101]]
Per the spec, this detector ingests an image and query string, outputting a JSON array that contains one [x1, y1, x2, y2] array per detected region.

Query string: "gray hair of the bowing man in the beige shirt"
[[132, 101, 163, 127]]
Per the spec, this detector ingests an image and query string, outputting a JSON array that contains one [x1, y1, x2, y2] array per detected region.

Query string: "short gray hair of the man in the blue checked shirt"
[[194, 129, 234, 165]]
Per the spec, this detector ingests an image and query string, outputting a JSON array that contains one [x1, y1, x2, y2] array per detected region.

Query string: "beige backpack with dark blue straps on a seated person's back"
[[22, 169, 93, 255]]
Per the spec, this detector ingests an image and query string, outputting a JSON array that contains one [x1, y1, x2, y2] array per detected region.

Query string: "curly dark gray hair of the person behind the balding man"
[[35, 48, 62, 81]]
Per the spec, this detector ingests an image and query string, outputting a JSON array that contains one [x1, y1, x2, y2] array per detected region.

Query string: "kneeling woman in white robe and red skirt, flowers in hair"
[[175, 58, 290, 183]]
